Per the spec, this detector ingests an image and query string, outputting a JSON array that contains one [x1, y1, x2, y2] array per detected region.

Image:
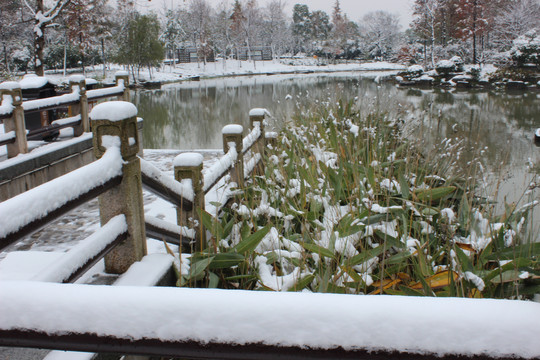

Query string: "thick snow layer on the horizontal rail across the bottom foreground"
[[0, 281, 540, 358]]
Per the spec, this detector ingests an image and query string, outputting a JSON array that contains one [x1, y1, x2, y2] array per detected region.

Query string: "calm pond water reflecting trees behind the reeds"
[[132, 72, 540, 238]]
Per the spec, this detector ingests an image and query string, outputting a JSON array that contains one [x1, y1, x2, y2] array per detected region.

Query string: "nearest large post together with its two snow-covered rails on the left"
[[0, 102, 146, 282]]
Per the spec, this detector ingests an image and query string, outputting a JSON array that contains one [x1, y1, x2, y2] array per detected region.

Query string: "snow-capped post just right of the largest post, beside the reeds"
[[173, 153, 206, 253]]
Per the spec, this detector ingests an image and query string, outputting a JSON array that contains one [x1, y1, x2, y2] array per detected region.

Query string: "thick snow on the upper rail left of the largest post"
[[0, 143, 122, 237]]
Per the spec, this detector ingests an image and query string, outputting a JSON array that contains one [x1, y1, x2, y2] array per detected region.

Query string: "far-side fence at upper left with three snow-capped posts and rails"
[[0, 72, 129, 158]]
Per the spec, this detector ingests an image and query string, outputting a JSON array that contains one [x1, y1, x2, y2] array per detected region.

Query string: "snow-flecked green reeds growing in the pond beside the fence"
[[178, 102, 540, 298]]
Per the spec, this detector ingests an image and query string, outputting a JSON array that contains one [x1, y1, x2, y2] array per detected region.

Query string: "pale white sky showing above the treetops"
[[137, 0, 412, 30]]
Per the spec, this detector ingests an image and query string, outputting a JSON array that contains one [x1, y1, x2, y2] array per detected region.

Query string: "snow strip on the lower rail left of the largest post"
[[32, 215, 128, 282]]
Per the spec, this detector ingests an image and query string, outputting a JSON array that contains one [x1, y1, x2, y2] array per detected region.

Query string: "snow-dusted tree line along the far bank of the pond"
[[0, 0, 540, 74]]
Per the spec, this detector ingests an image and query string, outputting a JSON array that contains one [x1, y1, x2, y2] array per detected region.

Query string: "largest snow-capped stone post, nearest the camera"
[[90, 101, 147, 274]]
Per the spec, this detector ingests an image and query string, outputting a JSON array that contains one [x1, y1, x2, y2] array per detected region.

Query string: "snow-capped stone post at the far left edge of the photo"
[[0, 81, 28, 158]]
